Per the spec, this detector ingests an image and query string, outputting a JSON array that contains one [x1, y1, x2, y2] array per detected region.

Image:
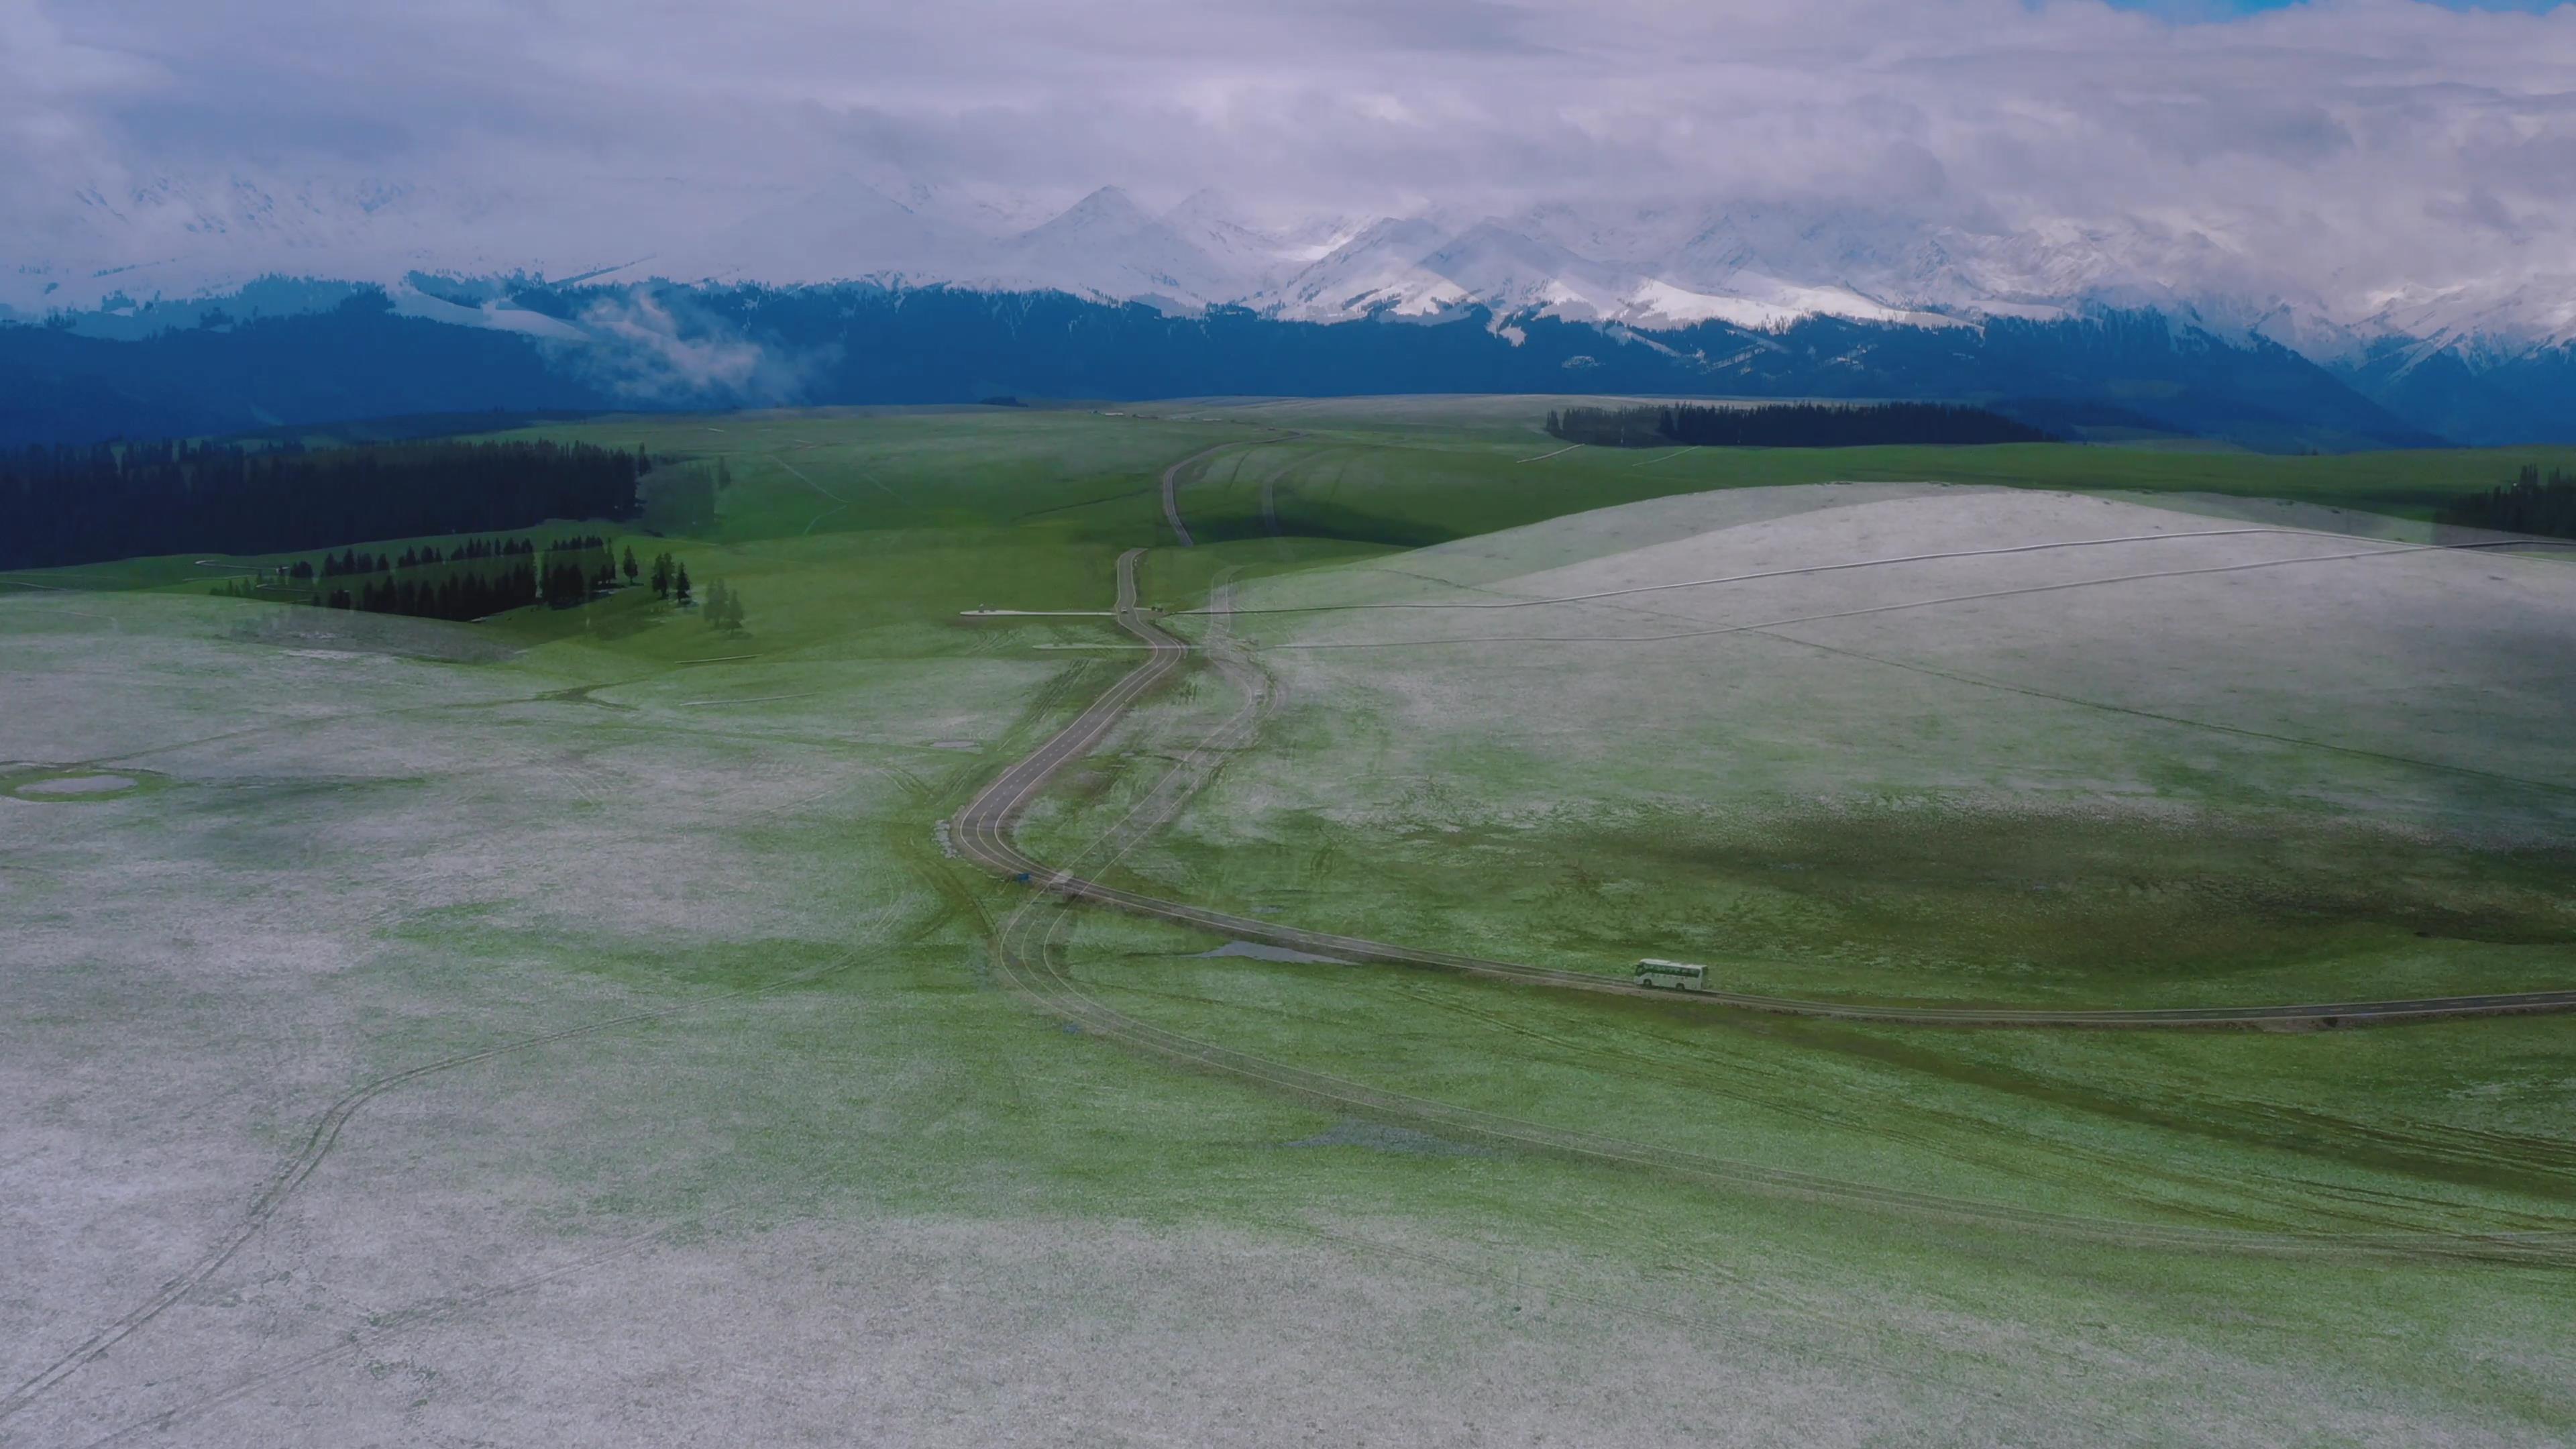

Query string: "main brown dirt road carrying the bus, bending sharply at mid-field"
[[951, 551, 2576, 1031]]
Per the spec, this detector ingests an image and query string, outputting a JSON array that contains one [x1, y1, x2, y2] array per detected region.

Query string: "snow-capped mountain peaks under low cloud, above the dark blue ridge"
[[15, 168, 2576, 438]]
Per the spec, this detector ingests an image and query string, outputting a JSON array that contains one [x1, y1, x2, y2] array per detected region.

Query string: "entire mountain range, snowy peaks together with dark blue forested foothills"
[[15, 178, 2576, 449]]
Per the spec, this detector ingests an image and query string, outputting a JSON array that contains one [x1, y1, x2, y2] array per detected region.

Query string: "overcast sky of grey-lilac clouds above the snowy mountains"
[[0, 0, 2576, 318]]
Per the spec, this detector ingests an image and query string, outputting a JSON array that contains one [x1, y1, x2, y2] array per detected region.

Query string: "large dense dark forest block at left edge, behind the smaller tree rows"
[[0, 443, 652, 568]]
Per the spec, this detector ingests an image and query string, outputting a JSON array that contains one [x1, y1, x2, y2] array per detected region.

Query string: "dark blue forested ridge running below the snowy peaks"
[[0, 284, 2452, 451]]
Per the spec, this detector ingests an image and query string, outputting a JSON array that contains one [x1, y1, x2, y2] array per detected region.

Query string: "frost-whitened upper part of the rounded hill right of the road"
[[1210, 485, 2576, 830]]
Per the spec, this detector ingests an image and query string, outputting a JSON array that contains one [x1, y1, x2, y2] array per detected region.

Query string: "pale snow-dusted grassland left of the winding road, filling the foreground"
[[0, 580, 2050, 1446]]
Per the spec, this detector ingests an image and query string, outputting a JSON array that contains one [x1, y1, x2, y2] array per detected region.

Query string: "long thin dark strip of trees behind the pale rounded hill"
[[1548, 402, 2055, 449]]
